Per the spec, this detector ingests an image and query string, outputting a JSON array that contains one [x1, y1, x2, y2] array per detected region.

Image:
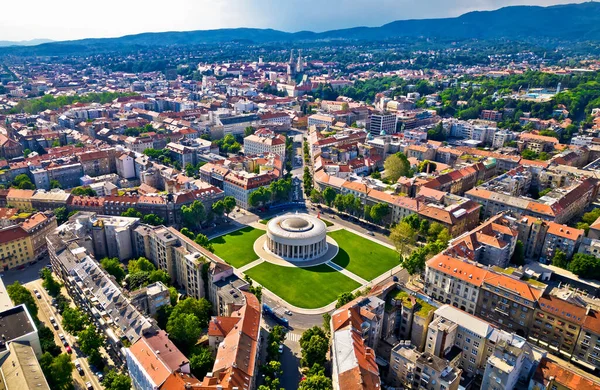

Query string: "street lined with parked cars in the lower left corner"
[[25, 278, 103, 389]]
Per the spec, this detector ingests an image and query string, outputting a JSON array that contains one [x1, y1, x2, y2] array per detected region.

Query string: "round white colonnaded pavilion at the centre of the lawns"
[[264, 214, 328, 262]]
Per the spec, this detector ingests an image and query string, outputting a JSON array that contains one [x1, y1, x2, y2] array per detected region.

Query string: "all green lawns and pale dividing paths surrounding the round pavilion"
[[210, 223, 399, 309]]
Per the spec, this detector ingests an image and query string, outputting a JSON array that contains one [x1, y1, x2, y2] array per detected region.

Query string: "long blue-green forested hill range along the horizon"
[[0, 2, 600, 55]]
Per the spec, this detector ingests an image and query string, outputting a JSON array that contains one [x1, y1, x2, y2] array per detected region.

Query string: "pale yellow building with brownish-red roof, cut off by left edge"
[[0, 226, 35, 270]]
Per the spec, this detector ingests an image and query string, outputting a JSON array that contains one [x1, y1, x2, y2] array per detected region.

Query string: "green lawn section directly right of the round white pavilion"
[[329, 230, 400, 280]]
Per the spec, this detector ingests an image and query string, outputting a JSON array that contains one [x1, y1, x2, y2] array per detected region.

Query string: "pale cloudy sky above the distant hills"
[[0, 0, 582, 41]]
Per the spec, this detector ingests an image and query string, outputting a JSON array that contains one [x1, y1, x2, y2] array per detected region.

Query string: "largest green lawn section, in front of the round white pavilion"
[[246, 262, 360, 309]]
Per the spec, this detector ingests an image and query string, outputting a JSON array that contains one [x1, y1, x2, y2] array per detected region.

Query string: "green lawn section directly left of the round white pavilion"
[[210, 226, 265, 268]]
